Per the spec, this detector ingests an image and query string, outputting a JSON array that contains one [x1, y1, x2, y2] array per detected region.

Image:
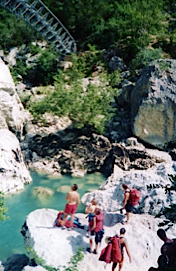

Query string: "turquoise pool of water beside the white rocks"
[[0, 172, 105, 261]]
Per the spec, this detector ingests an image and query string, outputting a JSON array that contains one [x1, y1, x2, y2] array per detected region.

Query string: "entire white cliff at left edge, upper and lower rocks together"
[[0, 59, 32, 193]]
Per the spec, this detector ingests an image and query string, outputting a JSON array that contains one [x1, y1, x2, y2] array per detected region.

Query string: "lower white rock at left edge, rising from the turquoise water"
[[0, 129, 32, 193]]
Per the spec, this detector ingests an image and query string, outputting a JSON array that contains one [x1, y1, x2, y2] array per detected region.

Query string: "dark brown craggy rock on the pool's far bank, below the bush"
[[23, 131, 111, 176]]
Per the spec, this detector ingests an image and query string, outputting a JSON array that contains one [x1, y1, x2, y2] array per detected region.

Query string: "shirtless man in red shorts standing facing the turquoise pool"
[[62, 184, 80, 230]]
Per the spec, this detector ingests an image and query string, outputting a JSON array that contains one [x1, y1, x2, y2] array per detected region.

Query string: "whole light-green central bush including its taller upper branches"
[[29, 52, 116, 133]]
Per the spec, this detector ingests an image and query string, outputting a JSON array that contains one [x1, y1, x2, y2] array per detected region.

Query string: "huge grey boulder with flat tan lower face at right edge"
[[131, 60, 176, 149]]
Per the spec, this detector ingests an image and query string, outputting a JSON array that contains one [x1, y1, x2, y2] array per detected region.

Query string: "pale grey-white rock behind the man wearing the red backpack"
[[81, 162, 176, 215]]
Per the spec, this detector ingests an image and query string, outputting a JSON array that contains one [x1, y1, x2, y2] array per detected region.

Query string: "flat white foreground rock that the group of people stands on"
[[23, 209, 176, 271]]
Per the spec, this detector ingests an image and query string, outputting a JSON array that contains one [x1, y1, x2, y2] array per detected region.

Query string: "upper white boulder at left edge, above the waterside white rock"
[[0, 58, 25, 138]]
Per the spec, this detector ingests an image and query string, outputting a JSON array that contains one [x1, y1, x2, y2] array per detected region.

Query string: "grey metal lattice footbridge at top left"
[[0, 0, 76, 55]]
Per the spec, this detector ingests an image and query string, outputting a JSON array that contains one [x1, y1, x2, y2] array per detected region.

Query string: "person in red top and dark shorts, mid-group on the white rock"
[[87, 208, 104, 254]]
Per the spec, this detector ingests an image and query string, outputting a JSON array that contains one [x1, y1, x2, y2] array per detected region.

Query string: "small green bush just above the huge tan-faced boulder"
[[131, 48, 163, 69]]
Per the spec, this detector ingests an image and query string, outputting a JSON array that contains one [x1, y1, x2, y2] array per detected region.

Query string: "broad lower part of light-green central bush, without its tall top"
[[29, 74, 117, 133]]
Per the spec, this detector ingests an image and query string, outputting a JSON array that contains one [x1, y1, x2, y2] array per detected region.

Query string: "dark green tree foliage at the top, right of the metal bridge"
[[44, 0, 167, 59]]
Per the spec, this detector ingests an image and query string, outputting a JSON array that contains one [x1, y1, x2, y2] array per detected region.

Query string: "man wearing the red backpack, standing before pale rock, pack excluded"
[[120, 183, 133, 224]]
